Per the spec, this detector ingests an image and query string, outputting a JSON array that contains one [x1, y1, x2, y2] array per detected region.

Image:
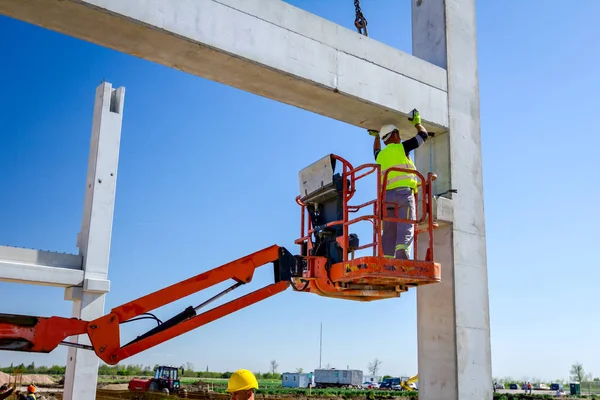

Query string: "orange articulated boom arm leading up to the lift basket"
[[0, 246, 296, 365]]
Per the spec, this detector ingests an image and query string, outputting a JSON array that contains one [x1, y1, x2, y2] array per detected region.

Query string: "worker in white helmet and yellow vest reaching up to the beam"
[[369, 109, 434, 260]]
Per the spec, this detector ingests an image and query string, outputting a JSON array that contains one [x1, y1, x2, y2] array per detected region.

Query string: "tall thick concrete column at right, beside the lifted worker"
[[412, 0, 493, 400]]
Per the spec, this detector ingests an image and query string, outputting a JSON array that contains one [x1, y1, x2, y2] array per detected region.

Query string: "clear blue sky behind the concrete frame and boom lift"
[[0, 0, 600, 380]]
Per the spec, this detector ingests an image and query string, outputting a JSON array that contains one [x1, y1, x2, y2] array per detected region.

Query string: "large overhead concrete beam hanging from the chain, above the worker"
[[0, 0, 448, 136]]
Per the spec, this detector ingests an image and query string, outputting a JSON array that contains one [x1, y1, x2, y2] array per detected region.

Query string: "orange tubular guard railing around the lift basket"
[[294, 155, 436, 261]]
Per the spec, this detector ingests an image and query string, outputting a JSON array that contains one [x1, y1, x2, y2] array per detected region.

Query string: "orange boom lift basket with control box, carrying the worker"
[[292, 154, 441, 301]]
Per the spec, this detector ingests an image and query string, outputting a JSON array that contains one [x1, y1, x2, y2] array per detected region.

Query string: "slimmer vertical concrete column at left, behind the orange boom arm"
[[64, 82, 125, 400]]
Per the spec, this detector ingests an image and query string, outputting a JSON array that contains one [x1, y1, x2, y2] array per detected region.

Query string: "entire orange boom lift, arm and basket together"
[[0, 154, 441, 365]]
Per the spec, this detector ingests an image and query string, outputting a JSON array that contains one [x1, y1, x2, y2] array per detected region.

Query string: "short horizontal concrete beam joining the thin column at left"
[[0, 246, 84, 287]]
